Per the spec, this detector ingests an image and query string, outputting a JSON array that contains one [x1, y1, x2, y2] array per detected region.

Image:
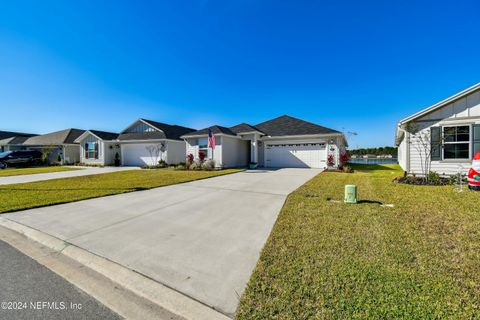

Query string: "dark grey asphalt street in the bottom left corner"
[[0, 241, 120, 319]]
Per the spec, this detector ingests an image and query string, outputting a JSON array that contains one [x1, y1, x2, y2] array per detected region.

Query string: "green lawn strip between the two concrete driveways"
[[0, 169, 240, 212]]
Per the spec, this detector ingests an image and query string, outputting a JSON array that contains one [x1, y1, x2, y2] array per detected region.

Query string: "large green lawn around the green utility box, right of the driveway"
[[236, 165, 480, 319]]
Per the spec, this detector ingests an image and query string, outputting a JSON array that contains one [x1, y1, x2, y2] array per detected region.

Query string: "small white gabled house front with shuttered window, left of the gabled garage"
[[75, 130, 121, 166]]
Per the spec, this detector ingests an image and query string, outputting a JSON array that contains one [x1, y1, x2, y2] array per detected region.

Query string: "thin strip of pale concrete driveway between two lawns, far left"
[[0, 167, 140, 185]]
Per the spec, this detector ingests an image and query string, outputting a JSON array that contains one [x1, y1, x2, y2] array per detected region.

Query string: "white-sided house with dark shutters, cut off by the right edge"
[[395, 83, 480, 175]]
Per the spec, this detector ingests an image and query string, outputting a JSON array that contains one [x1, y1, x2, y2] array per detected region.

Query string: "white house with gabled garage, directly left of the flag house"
[[117, 119, 195, 166]]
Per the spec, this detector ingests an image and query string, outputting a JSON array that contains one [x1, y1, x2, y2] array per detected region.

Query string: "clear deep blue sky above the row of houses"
[[0, 0, 480, 148]]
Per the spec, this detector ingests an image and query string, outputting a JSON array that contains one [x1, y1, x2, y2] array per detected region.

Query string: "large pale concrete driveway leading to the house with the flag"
[[2, 169, 321, 315]]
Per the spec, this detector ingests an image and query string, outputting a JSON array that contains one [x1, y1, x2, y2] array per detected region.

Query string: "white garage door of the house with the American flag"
[[265, 142, 327, 168]]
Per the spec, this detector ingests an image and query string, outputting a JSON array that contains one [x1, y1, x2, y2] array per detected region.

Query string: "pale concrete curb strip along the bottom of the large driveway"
[[0, 217, 231, 320]]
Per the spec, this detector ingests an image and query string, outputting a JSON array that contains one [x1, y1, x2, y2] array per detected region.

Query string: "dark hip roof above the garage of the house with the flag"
[[255, 115, 341, 137]]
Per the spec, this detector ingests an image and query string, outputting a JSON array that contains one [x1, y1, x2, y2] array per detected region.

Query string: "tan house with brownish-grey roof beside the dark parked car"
[[22, 128, 85, 164]]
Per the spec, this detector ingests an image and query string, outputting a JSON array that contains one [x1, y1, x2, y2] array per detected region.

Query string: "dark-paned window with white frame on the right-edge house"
[[443, 126, 470, 159]]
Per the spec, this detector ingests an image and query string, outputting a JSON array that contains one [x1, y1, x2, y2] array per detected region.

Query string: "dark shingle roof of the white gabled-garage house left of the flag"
[[118, 119, 195, 140]]
